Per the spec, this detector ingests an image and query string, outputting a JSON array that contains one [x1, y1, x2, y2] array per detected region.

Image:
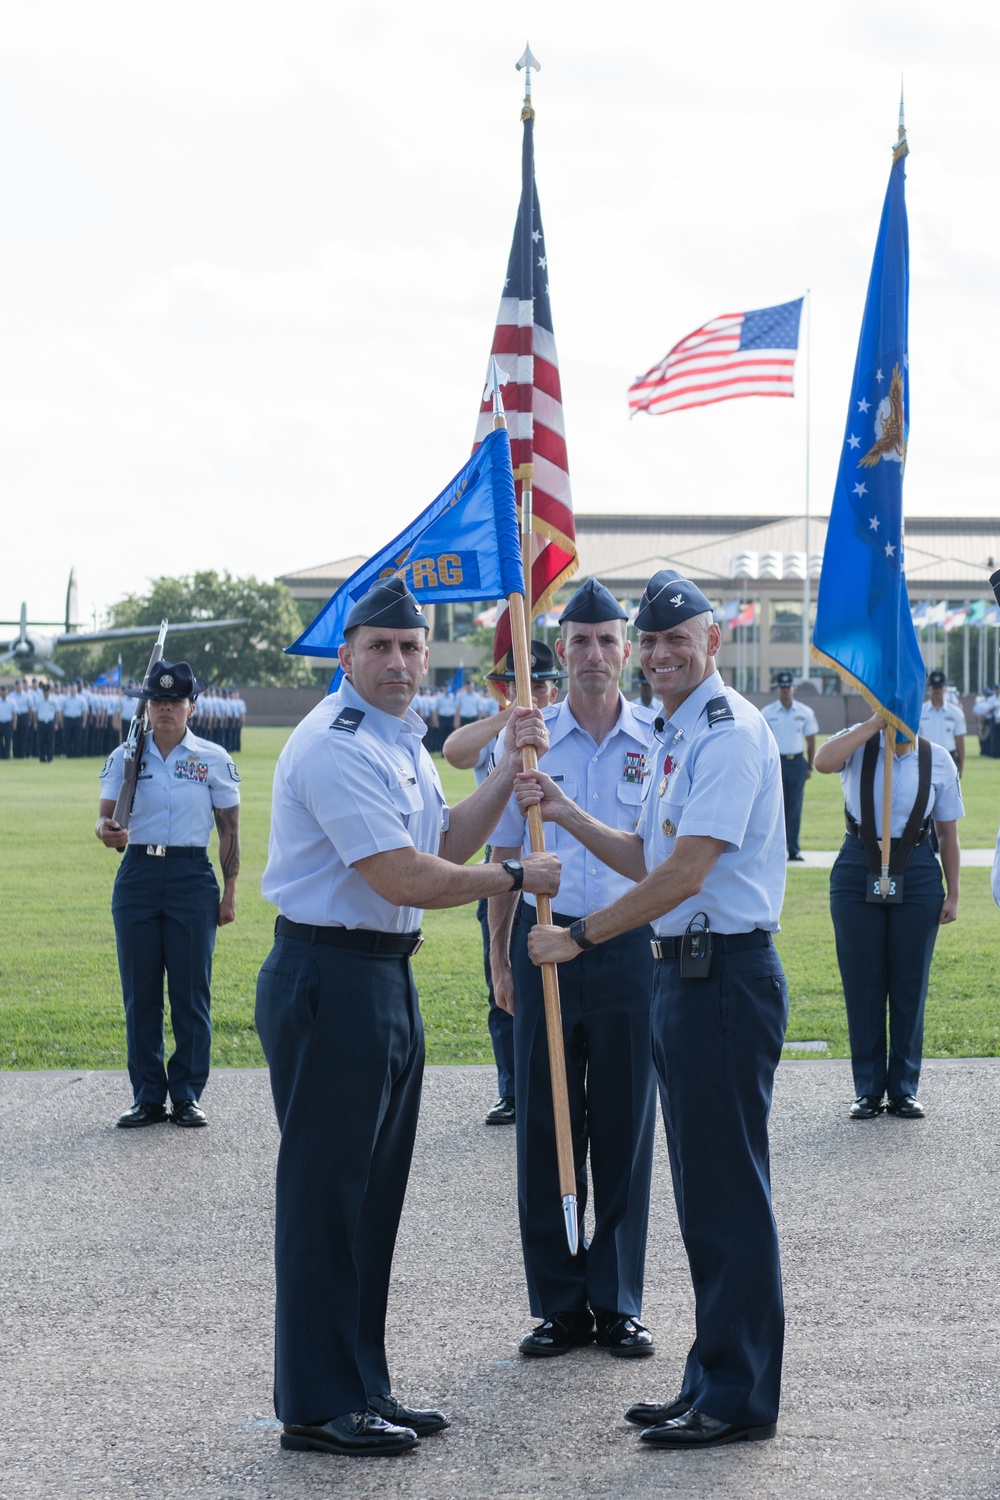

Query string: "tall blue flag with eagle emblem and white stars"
[[813, 119, 927, 747]]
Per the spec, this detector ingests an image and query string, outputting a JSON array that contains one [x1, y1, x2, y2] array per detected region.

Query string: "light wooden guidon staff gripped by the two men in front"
[[493, 360, 580, 1256]]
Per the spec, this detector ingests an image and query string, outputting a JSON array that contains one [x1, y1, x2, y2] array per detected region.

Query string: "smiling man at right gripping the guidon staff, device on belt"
[[519, 570, 787, 1449]]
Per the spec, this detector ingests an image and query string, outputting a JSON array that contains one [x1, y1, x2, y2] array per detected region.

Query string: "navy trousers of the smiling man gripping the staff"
[[652, 945, 789, 1427]]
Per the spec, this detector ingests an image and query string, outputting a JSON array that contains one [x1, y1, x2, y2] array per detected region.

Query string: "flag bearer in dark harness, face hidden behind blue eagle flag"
[[816, 716, 966, 1121]]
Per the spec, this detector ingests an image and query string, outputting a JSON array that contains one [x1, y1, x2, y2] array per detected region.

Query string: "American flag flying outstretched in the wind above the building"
[[628, 297, 802, 417]]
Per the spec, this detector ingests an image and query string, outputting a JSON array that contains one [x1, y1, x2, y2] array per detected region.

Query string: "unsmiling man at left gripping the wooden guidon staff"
[[256, 578, 559, 1455]]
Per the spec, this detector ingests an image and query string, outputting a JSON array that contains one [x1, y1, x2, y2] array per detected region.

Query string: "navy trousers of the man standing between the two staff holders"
[[510, 903, 657, 1317]]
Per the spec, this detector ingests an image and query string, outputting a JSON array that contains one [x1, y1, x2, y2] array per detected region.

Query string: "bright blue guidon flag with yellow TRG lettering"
[[285, 428, 525, 657]]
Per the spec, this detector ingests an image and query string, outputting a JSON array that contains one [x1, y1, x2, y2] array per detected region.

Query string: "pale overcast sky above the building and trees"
[[0, 0, 1000, 623]]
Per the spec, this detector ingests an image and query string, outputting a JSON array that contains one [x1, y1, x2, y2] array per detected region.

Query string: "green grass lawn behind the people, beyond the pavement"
[[0, 729, 1000, 1070]]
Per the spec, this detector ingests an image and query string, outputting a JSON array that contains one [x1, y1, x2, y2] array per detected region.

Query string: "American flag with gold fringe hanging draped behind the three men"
[[472, 105, 579, 663]]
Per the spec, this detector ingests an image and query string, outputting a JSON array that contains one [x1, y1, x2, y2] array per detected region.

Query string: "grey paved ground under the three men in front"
[[0, 1059, 1000, 1500]]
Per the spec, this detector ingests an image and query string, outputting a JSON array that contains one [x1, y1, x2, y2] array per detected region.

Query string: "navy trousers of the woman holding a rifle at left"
[[111, 849, 219, 1104]]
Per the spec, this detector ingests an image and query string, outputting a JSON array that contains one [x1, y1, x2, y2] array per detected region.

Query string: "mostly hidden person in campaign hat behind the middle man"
[[441, 641, 565, 1125]]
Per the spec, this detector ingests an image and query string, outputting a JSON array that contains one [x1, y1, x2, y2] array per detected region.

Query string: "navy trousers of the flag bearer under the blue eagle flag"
[[831, 834, 945, 1100]]
